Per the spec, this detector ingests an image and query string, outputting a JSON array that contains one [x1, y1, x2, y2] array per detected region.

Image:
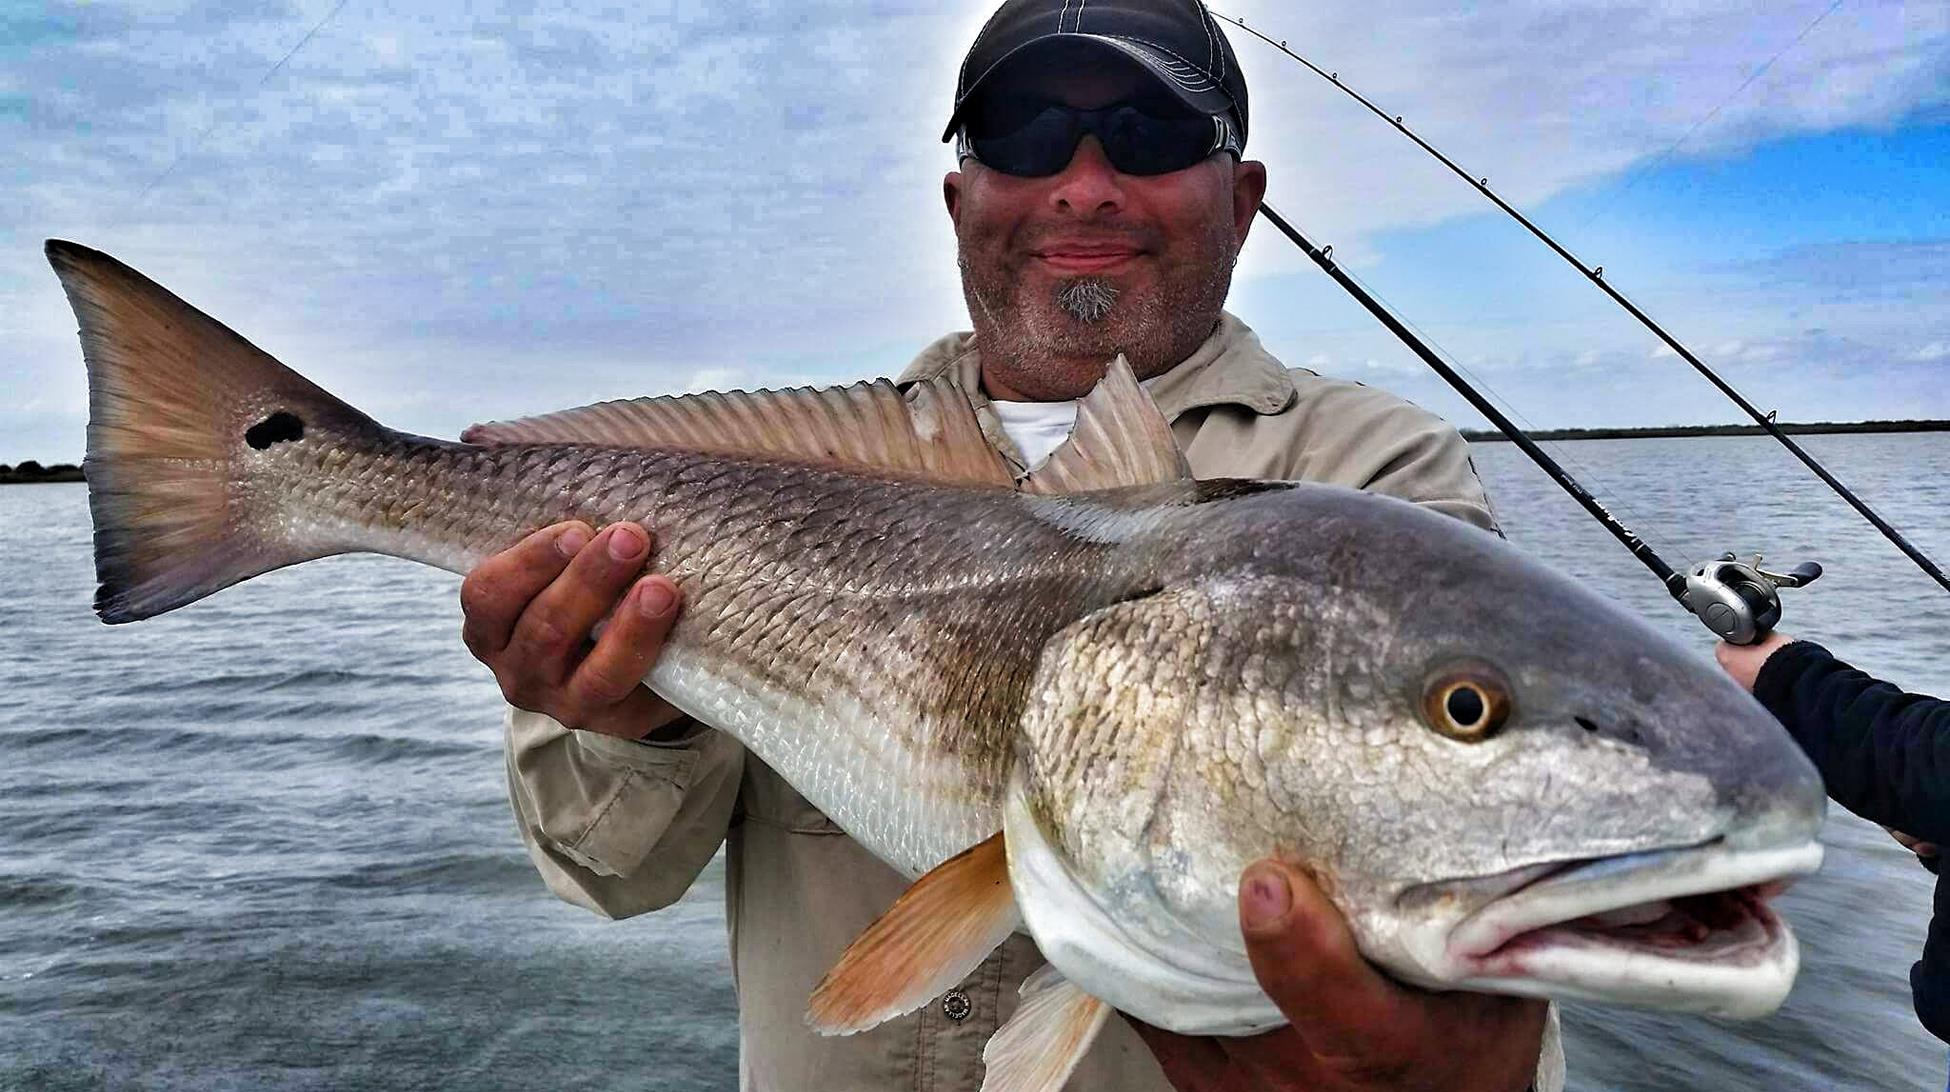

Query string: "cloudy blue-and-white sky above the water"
[[0, 0, 1950, 462]]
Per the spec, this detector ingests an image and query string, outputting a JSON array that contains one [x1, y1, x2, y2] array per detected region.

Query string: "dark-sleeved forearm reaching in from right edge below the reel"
[[1753, 642, 1950, 842]]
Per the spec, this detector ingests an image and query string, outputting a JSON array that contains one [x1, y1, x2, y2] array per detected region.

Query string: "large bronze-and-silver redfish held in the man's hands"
[[47, 242, 1823, 1092]]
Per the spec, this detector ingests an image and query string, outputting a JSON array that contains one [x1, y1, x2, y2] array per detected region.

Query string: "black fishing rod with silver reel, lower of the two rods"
[[1260, 203, 1821, 645]]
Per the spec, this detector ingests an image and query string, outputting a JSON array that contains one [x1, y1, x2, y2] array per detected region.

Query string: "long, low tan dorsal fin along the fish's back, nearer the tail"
[[460, 376, 1012, 488]]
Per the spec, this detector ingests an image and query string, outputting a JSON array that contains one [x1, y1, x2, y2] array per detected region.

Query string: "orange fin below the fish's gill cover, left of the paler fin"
[[805, 831, 1022, 1035]]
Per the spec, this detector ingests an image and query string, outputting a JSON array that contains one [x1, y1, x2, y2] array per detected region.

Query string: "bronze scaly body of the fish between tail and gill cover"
[[254, 423, 1154, 874]]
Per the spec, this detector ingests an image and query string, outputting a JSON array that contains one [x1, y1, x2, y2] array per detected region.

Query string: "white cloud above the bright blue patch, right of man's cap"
[[1232, 0, 1950, 259]]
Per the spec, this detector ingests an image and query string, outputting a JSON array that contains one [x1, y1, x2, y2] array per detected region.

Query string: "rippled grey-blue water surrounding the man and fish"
[[0, 435, 1950, 1092]]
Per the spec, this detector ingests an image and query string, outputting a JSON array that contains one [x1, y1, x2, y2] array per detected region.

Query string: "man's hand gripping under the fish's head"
[[1137, 860, 1548, 1092]]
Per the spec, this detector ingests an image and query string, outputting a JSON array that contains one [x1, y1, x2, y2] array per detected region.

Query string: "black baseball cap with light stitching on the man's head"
[[942, 0, 1246, 144]]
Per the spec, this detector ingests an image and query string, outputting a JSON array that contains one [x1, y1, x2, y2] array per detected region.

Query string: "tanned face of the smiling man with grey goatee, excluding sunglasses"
[[944, 60, 1266, 402]]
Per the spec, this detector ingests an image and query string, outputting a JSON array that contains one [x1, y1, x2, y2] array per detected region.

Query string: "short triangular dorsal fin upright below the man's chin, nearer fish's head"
[[1020, 355, 1191, 493]]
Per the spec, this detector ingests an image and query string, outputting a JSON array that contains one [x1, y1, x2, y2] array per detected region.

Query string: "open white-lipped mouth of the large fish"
[[1445, 839, 1821, 1020]]
